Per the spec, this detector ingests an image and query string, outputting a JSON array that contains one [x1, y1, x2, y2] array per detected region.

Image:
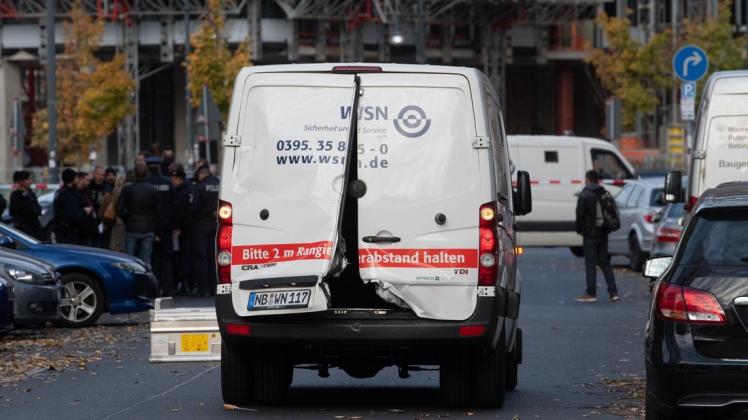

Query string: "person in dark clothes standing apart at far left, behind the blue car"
[[9, 170, 44, 240]]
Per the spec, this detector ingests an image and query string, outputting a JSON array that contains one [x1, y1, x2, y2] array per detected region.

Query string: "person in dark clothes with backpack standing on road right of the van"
[[576, 170, 621, 303]]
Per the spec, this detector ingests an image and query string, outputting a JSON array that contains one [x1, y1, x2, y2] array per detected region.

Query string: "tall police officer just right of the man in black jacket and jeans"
[[145, 156, 174, 296]]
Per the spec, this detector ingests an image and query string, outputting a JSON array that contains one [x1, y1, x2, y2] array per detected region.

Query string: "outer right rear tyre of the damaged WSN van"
[[472, 332, 507, 408]]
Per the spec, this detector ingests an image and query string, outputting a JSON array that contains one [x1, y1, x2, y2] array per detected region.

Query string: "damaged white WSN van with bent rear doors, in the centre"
[[216, 64, 531, 407]]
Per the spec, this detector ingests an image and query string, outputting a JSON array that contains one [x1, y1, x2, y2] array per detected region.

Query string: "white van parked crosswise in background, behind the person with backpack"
[[507, 135, 635, 256]]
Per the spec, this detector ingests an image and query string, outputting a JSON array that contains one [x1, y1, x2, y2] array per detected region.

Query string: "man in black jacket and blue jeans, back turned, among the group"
[[117, 163, 158, 265]]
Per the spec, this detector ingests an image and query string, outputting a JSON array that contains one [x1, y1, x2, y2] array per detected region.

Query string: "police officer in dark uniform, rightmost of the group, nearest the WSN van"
[[190, 164, 219, 296]]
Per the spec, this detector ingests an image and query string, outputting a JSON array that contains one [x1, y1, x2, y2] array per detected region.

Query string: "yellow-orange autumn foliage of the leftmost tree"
[[32, 0, 134, 166]]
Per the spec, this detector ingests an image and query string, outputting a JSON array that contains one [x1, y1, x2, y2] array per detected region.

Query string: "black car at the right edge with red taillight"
[[644, 182, 748, 419]]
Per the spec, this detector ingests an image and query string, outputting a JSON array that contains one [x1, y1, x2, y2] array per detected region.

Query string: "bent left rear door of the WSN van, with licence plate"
[[228, 73, 354, 316]]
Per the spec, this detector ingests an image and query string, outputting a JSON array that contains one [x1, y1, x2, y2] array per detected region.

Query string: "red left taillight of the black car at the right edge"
[[657, 282, 727, 325]]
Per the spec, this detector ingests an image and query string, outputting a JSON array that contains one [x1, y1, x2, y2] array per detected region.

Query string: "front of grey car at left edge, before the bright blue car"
[[0, 246, 62, 327]]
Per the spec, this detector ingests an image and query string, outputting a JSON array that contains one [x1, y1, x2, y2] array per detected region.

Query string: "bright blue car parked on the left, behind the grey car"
[[0, 224, 158, 327]]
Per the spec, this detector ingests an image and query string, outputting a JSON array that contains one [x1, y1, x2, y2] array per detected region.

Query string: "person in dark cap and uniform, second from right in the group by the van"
[[169, 163, 194, 294]]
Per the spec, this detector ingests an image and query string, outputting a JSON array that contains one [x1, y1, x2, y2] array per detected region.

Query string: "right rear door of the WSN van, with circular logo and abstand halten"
[[357, 73, 486, 320]]
